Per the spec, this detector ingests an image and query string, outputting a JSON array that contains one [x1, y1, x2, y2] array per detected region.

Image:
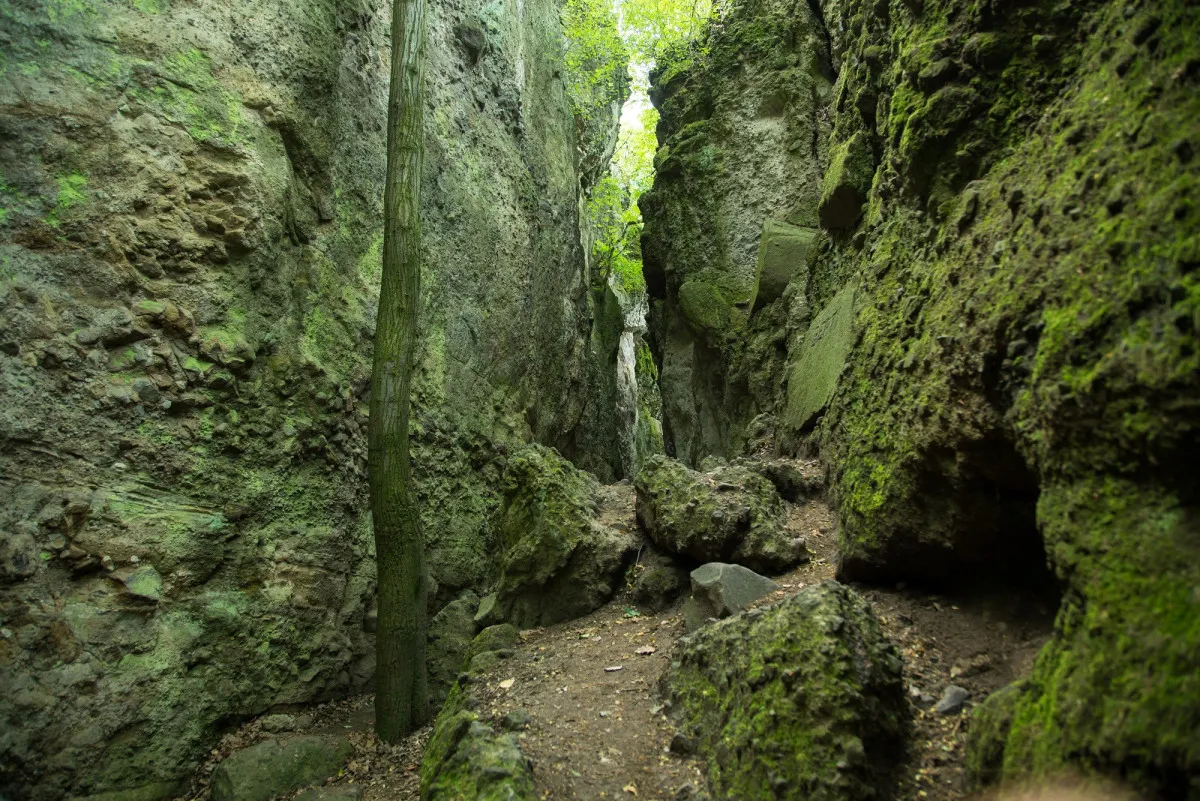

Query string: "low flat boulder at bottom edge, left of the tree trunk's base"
[[212, 737, 354, 801]]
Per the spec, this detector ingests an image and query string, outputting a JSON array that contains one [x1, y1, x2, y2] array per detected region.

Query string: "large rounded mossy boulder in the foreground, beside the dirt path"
[[664, 582, 910, 801]]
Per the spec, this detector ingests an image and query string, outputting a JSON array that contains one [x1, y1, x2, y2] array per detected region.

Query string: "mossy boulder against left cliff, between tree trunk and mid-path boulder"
[[497, 445, 637, 627]]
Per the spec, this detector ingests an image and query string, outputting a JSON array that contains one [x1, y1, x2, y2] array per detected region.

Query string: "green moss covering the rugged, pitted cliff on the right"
[[810, 2, 1200, 796]]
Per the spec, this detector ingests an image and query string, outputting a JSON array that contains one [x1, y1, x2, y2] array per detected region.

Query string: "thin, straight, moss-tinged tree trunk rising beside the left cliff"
[[367, 0, 428, 742]]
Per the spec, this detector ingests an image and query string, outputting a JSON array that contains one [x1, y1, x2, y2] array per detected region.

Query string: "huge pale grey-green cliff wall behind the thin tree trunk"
[[0, 0, 616, 799]]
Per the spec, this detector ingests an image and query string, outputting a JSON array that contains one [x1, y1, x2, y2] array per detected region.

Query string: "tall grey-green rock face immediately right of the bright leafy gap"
[[641, 0, 830, 465]]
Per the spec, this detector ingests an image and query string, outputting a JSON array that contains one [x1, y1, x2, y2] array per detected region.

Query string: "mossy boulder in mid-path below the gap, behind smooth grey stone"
[[634, 456, 808, 572]]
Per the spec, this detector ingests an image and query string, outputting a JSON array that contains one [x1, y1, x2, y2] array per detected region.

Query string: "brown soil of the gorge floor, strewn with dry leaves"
[[182, 472, 1057, 801]]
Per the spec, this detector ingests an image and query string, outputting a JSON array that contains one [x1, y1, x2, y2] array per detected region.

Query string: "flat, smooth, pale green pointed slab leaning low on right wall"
[[782, 284, 854, 430]]
